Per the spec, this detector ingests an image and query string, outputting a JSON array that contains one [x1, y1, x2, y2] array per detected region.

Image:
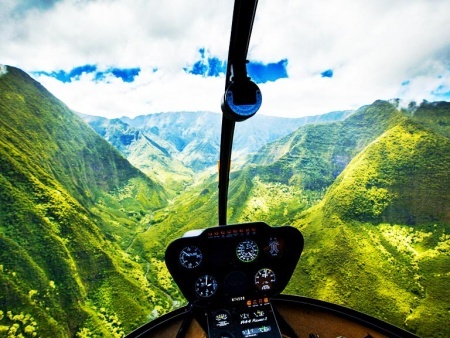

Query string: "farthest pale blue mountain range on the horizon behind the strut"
[[122, 111, 352, 172]]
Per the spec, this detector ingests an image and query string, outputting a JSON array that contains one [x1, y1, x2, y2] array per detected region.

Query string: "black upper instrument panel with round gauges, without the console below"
[[165, 222, 304, 306]]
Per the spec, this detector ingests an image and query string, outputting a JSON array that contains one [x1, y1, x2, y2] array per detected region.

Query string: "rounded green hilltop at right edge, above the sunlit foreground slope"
[[325, 117, 450, 225]]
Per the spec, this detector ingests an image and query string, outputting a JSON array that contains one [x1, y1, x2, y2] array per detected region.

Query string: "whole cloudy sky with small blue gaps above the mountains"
[[0, 0, 450, 117]]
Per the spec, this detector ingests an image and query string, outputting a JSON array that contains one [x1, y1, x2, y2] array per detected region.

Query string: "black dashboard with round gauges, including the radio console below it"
[[165, 222, 304, 338]]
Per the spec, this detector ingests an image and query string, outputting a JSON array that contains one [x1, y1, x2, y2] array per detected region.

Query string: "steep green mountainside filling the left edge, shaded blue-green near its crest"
[[0, 67, 172, 337]]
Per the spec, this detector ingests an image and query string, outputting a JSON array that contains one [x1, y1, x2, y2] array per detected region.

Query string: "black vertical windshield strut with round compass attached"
[[219, 0, 262, 225]]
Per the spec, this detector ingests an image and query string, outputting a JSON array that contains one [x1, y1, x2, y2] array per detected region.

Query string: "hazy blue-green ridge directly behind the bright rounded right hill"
[[251, 101, 405, 192]]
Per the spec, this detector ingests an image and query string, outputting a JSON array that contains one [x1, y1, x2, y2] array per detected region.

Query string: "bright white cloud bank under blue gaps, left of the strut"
[[37, 69, 225, 118]]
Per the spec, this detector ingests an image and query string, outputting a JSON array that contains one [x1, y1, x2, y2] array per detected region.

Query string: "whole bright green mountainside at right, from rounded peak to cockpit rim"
[[288, 114, 450, 337]]
